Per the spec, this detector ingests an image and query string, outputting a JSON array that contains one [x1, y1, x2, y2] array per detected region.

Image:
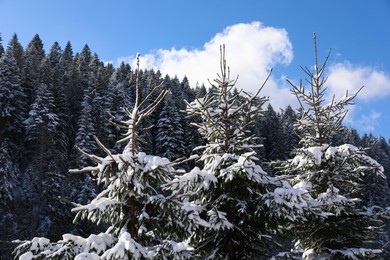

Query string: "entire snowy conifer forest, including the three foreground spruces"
[[0, 34, 390, 259]]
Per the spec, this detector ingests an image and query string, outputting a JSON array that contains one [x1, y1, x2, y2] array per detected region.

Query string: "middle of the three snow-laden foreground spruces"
[[166, 46, 316, 259]]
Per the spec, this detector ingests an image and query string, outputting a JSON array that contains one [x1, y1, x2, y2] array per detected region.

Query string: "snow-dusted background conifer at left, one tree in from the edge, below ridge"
[[25, 84, 64, 236]]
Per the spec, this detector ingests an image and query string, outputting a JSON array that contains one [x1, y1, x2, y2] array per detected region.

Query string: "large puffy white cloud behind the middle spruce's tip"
[[120, 22, 295, 108]]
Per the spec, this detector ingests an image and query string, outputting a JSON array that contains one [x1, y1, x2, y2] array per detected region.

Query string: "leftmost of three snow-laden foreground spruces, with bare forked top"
[[15, 53, 199, 259]]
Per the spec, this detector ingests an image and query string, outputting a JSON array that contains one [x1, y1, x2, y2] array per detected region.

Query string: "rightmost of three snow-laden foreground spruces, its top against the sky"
[[275, 34, 388, 259]]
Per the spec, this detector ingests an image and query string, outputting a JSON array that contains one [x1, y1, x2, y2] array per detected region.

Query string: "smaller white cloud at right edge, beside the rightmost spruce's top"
[[327, 62, 390, 101]]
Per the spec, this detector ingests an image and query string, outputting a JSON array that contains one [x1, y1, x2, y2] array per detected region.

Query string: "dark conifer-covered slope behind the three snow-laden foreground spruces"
[[0, 34, 390, 255]]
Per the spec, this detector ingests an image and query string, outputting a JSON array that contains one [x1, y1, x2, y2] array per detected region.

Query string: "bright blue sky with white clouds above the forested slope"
[[0, 0, 390, 138]]
